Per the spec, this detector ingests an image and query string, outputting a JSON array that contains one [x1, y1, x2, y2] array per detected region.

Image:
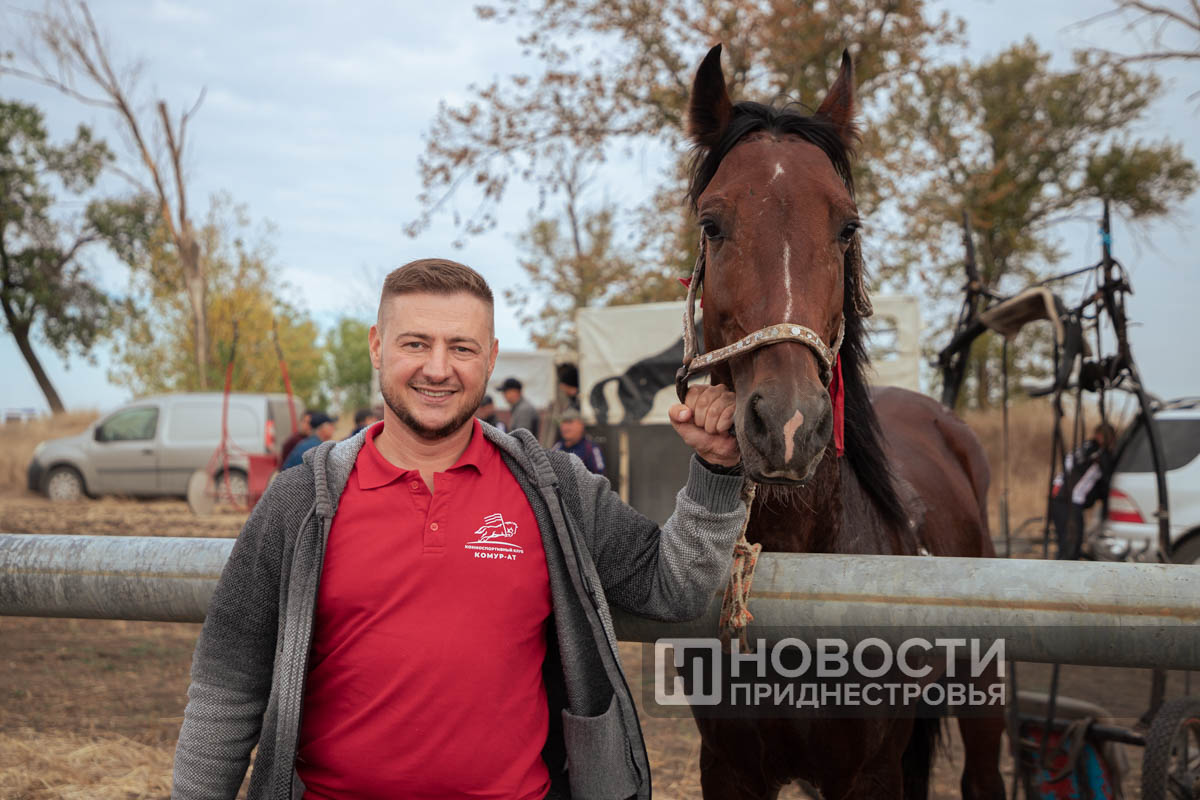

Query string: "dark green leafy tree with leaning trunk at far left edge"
[[0, 102, 112, 413]]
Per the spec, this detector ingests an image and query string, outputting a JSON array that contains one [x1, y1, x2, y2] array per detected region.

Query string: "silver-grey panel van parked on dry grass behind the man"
[[28, 392, 302, 500]]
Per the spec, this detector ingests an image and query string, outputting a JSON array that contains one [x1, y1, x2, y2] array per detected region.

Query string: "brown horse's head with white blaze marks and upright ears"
[[689, 44, 870, 485]]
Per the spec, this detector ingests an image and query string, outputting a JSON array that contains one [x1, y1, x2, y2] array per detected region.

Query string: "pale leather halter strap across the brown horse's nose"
[[676, 243, 846, 403]]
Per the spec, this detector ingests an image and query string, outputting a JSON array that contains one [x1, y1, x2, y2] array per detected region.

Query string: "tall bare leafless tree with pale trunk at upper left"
[[0, 0, 209, 387]]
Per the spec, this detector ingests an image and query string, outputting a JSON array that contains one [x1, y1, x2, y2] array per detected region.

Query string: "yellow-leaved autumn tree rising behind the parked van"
[[110, 197, 323, 403]]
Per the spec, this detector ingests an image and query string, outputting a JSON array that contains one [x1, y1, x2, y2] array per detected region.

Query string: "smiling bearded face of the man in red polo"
[[371, 291, 497, 440]]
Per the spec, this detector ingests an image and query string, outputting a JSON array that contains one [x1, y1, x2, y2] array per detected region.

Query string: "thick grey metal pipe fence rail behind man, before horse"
[[0, 534, 1200, 669]]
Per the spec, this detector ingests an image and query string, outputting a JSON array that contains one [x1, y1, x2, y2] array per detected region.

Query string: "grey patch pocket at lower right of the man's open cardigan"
[[563, 693, 638, 800]]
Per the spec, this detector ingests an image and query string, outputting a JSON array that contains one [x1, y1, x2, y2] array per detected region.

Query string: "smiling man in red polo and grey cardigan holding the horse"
[[173, 259, 745, 800]]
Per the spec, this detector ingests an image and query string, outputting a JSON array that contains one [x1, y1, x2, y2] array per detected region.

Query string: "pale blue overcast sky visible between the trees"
[[0, 0, 1200, 410]]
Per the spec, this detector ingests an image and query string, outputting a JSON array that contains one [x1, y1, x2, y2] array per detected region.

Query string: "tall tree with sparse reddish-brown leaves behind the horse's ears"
[[408, 0, 961, 256]]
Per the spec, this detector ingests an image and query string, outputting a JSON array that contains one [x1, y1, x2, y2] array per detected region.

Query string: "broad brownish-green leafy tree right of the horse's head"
[[883, 41, 1198, 405]]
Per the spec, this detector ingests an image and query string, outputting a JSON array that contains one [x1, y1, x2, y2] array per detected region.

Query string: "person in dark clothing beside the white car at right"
[[1050, 422, 1117, 561]]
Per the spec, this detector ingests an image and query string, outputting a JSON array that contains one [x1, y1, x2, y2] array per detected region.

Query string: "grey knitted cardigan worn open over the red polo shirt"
[[172, 425, 745, 800]]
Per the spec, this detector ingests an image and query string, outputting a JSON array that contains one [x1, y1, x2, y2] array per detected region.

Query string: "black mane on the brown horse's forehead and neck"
[[688, 102, 908, 527]]
